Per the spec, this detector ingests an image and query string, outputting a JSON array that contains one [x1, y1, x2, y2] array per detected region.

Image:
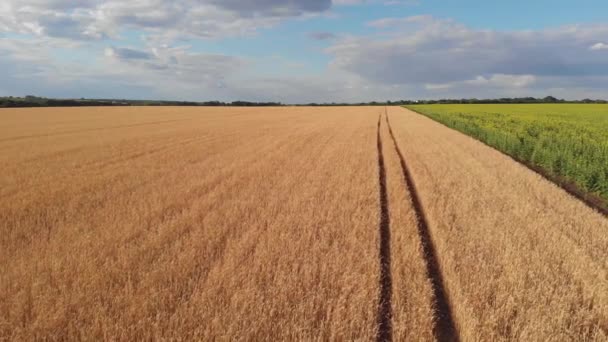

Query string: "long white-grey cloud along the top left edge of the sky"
[[0, 0, 331, 40]]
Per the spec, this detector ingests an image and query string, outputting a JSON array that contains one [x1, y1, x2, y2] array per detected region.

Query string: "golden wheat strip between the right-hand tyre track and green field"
[[388, 108, 608, 341]]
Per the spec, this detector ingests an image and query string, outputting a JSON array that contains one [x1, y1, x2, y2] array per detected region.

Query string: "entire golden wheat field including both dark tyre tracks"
[[0, 106, 608, 341]]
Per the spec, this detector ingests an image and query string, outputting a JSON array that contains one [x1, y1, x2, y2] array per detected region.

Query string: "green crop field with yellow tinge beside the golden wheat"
[[407, 104, 608, 203]]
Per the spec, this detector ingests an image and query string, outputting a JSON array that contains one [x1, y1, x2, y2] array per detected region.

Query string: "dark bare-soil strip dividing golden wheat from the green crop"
[[401, 107, 608, 218]]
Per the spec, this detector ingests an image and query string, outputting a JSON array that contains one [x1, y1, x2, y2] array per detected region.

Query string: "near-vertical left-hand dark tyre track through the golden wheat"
[[376, 113, 393, 342]]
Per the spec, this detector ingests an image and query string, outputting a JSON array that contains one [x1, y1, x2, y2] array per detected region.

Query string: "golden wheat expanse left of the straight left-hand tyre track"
[[0, 108, 406, 340]]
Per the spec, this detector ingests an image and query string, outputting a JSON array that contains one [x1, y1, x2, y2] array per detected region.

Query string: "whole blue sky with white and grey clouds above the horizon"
[[0, 0, 608, 103]]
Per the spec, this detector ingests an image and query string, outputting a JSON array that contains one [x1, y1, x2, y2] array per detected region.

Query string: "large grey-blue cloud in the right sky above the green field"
[[327, 16, 608, 89]]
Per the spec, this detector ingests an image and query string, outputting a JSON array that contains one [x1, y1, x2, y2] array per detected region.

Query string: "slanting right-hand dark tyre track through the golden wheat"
[[385, 109, 460, 342]]
